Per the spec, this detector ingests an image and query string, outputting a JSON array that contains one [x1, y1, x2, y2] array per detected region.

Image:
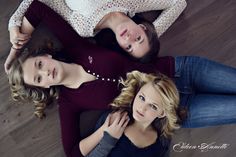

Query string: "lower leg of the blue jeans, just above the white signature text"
[[182, 94, 236, 128]]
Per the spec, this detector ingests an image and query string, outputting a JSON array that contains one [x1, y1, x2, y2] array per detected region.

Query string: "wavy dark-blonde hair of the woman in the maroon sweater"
[[8, 49, 58, 119]]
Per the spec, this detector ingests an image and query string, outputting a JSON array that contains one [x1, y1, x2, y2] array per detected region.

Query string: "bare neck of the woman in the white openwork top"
[[96, 12, 131, 32]]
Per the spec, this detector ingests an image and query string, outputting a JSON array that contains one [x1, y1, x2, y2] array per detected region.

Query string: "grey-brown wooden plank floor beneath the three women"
[[0, 0, 236, 157]]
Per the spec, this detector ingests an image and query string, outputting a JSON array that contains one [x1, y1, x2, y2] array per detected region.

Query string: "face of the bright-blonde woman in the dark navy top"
[[133, 83, 165, 124]]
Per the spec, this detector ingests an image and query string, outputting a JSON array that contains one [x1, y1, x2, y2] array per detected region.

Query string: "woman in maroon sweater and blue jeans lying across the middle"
[[9, 1, 236, 156]]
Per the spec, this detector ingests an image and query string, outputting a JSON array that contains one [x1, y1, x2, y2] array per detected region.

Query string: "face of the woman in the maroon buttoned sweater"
[[22, 55, 63, 88]]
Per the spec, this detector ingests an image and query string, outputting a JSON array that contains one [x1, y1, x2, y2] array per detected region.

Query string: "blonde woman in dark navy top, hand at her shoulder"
[[80, 71, 179, 157]]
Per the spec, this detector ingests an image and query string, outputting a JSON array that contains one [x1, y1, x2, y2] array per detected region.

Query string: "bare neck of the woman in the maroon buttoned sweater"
[[62, 64, 91, 88]]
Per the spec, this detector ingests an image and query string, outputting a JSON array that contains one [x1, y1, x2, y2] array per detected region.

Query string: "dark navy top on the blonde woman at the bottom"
[[87, 111, 170, 157]]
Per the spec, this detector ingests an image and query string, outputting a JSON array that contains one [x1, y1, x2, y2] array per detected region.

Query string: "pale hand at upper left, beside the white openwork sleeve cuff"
[[9, 26, 31, 49]]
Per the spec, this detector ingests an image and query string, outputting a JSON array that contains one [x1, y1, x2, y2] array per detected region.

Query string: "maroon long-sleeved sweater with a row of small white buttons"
[[25, 0, 174, 157]]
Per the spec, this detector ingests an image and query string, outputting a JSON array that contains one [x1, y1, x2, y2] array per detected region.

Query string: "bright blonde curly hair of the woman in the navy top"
[[111, 71, 179, 137]]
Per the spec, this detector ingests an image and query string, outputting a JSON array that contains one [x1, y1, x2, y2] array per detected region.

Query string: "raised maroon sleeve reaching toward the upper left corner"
[[25, 0, 85, 48]]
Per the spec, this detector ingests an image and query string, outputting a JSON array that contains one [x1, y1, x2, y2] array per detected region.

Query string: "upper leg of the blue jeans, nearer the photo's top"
[[176, 56, 236, 94]]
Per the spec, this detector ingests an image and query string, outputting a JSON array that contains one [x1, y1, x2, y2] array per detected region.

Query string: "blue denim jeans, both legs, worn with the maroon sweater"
[[175, 56, 236, 128]]
